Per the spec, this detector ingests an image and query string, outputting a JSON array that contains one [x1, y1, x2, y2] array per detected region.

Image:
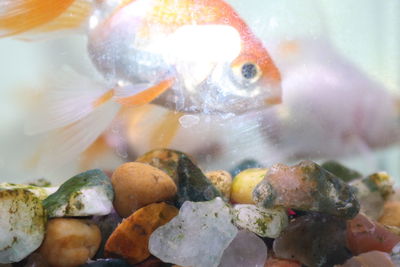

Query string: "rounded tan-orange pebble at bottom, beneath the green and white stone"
[[38, 218, 101, 267]]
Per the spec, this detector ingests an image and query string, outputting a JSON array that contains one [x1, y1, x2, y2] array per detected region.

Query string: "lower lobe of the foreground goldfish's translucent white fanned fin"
[[38, 101, 120, 170]]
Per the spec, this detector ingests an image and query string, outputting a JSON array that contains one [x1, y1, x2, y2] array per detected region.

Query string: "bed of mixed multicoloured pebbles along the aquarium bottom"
[[0, 149, 400, 267]]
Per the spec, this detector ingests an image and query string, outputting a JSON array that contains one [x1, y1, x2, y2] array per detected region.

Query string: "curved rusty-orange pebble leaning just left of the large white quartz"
[[105, 203, 178, 264]]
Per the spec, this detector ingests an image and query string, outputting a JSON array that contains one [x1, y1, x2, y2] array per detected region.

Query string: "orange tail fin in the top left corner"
[[0, 0, 92, 37]]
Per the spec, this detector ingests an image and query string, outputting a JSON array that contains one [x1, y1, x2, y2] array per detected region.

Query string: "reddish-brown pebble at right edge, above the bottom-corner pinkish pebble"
[[347, 214, 400, 255]]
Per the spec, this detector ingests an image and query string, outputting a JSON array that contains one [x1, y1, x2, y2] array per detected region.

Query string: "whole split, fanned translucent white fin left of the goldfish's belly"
[[25, 68, 121, 171]]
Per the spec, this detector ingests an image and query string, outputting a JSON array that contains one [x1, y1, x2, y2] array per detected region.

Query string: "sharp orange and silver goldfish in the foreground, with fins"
[[0, 0, 281, 170]]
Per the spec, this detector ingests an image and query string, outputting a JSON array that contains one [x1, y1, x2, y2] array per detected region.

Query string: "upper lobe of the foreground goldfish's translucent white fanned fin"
[[25, 71, 114, 135]]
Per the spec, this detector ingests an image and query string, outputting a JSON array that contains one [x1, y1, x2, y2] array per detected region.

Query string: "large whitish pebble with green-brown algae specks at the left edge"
[[0, 188, 47, 264]]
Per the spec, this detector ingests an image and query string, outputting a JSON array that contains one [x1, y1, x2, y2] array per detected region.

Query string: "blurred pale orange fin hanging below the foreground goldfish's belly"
[[150, 111, 183, 149]]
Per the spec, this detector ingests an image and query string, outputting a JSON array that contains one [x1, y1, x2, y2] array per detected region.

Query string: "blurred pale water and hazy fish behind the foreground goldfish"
[[0, 0, 400, 183]]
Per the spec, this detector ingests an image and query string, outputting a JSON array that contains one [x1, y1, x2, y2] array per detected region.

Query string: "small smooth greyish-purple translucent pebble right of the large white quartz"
[[219, 230, 268, 267]]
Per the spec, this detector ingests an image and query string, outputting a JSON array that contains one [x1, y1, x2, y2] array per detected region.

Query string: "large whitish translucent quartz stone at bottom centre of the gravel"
[[149, 198, 238, 267]]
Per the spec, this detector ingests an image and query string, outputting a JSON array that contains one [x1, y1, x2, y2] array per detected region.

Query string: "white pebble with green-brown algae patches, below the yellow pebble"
[[233, 204, 288, 238]]
